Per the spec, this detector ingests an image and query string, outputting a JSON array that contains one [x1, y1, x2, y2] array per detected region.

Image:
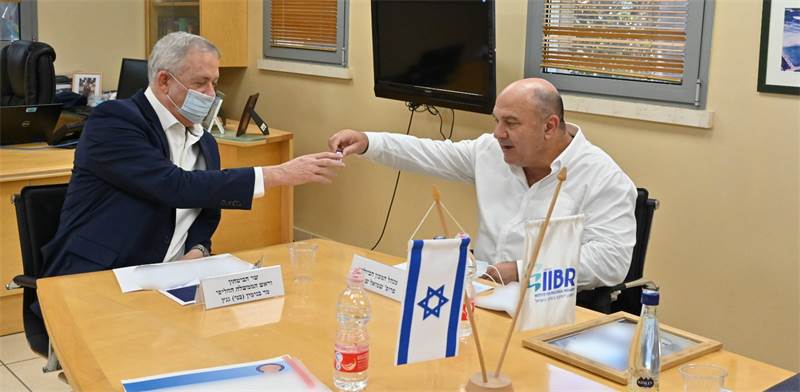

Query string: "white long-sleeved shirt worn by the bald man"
[[364, 124, 637, 290]]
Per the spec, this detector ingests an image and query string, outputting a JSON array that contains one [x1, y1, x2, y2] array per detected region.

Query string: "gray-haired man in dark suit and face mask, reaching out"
[[42, 33, 344, 276]]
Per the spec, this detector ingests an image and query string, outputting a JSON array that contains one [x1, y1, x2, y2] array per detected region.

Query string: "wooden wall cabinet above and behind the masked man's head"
[[145, 0, 247, 67]]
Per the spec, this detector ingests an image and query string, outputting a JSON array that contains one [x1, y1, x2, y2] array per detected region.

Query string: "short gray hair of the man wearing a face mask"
[[147, 31, 220, 83]]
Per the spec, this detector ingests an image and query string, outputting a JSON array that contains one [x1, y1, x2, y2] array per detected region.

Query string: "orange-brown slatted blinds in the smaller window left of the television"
[[270, 0, 337, 52]]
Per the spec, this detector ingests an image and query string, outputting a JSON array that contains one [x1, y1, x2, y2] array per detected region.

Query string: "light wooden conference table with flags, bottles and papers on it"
[[39, 240, 792, 391]]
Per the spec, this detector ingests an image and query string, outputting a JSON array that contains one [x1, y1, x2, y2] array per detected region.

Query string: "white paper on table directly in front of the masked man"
[[113, 253, 253, 293]]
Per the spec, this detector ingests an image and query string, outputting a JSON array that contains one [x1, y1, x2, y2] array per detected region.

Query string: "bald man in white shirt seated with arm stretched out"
[[328, 79, 636, 290]]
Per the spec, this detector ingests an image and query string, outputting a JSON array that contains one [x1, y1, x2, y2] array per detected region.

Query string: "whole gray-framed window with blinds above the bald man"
[[525, 0, 715, 109]]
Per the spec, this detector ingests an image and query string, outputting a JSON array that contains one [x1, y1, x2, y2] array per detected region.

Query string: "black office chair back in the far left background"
[[0, 40, 56, 106]]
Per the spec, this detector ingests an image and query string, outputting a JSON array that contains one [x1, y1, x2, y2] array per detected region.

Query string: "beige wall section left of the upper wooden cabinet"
[[38, 0, 145, 90]]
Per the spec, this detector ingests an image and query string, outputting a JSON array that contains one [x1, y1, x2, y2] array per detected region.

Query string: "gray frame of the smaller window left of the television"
[[263, 0, 349, 67]]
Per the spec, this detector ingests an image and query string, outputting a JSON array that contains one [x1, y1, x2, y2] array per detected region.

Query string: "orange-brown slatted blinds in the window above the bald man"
[[541, 0, 689, 84]]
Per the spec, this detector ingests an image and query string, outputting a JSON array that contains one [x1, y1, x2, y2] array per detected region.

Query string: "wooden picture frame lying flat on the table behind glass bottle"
[[522, 312, 722, 385]]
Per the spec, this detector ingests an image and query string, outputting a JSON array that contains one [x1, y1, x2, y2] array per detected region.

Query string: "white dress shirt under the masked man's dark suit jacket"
[[144, 87, 264, 261]]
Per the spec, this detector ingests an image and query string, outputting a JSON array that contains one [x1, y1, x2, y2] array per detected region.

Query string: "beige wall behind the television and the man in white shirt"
[[216, 0, 800, 371]]
